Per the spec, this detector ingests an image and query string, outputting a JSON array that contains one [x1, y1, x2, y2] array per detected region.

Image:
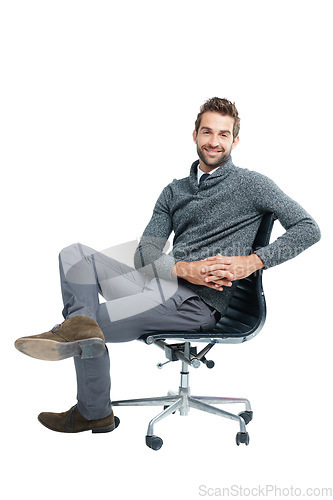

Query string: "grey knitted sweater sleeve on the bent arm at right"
[[250, 172, 321, 269]]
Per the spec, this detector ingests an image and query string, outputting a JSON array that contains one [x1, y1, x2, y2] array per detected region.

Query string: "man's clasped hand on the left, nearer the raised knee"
[[172, 255, 235, 291]]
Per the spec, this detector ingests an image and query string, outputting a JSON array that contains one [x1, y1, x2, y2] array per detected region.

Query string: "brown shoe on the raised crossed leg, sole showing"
[[15, 316, 105, 361]]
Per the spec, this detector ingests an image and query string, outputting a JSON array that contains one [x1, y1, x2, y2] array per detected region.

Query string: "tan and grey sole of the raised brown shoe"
[[15, 338, 105, 361]]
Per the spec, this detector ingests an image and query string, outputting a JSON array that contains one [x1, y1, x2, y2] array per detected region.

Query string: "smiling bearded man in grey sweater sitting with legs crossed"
[[15, 97, 320, 432]]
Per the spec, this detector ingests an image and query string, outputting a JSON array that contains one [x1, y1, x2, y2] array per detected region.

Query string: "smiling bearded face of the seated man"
[[193, 111, 239, 172]]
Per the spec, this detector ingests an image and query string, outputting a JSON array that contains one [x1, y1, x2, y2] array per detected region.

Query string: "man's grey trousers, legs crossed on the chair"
[[59, 243, 216, 420]]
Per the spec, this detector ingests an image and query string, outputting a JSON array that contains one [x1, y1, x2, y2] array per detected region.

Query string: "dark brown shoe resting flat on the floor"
[[38, 405, 120, 434]]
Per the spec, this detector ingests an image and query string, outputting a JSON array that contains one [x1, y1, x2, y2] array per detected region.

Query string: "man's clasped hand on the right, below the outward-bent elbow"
[[204, 254, 264, 288]]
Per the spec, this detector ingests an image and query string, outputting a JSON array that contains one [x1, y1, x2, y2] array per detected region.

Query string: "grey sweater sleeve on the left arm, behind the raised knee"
[[134, 186, 176, 279]]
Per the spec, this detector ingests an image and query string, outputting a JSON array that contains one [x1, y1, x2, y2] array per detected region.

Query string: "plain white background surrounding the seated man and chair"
[[0, 0, 333, 500]]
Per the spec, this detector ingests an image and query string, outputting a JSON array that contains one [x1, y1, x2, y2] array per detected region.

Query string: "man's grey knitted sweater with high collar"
[[134, 157, 320, 314]]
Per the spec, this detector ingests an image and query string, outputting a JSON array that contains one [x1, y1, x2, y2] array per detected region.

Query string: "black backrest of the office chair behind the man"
[[214, 213, 275, 338]]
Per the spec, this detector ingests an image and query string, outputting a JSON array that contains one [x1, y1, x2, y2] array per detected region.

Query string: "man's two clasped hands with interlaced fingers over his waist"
[[173, 254, 264, 291]]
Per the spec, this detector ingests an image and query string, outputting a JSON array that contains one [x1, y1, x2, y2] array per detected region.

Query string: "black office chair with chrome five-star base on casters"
[[112, 213, 275, 450]]
